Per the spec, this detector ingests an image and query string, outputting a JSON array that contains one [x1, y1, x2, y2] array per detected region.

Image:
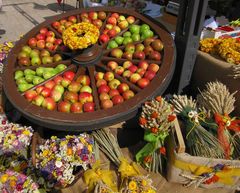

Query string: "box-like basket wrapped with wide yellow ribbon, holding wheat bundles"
[[167, 120, 240, 190]]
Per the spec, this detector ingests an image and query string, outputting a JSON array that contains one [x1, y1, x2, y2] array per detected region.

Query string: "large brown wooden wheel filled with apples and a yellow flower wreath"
[[3, 7, 174, 131]]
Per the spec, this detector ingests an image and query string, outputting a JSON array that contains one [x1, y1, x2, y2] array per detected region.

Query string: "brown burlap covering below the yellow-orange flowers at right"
[[191, 51, 240, 116]]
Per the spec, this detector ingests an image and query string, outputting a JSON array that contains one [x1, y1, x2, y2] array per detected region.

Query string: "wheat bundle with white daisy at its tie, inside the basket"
[[171, 95, 223, 158]]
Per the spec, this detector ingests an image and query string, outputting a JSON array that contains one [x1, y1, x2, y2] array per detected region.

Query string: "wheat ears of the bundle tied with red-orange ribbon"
[[197, 81, 236, 115]]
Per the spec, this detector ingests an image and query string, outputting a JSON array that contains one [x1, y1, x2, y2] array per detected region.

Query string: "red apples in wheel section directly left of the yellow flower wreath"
[[28, 27, 62, 51]]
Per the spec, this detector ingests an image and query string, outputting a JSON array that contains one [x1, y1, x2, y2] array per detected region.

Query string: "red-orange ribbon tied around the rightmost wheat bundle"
[[214, 113, 240, 159]]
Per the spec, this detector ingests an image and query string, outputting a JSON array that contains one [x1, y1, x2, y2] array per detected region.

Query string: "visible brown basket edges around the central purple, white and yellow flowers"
[[31, 132, 84, 189]]
